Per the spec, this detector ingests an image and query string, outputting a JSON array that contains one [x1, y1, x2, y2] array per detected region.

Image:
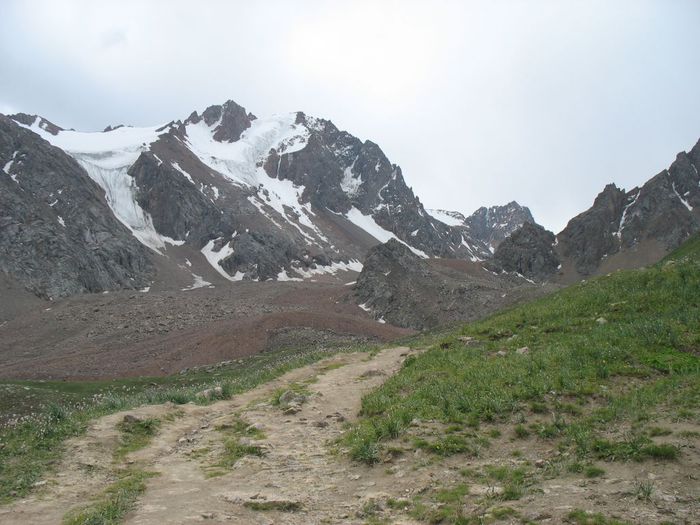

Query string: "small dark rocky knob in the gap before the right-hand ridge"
[[493, 222, 560, 281]]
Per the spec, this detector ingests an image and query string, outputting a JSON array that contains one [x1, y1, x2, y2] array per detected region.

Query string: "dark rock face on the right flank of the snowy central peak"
[[264, 113, 466, 257]]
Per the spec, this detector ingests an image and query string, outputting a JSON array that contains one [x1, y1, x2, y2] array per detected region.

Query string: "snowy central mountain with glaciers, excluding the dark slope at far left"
[[0, 101, 520, 295]]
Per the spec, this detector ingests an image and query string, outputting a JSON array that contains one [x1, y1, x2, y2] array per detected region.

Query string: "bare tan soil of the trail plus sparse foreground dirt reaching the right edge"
[[0, 347, 700, 525]]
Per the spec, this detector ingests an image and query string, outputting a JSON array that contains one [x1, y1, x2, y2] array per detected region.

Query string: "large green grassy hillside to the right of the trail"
[[344, 239, 700, 463]]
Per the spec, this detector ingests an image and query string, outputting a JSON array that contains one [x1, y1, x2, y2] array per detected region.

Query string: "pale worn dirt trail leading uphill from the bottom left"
[[0, 347, 422, 525]]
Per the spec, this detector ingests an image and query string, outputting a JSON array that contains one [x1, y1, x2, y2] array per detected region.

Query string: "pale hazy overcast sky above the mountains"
[[0, 0, 700, 231]]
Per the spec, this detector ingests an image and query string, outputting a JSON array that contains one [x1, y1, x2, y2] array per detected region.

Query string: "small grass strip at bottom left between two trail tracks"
[[63, 469, 154, 525]]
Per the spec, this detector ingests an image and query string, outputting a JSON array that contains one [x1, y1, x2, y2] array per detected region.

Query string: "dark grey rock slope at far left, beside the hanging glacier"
[[0, 115, 153, 298]]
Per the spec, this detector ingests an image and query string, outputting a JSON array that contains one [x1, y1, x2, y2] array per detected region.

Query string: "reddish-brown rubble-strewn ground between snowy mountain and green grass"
[[0, 274, 411, 379]]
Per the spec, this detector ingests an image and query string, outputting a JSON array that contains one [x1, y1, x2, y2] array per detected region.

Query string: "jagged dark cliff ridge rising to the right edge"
[[557, 142, 700, 276]]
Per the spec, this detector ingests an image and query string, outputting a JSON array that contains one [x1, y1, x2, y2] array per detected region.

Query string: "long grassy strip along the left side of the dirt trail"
[[0, 346, 378, 504]]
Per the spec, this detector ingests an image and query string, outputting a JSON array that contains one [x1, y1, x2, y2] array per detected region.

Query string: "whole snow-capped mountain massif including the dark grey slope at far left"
[[0, 101, 524, 297]]
